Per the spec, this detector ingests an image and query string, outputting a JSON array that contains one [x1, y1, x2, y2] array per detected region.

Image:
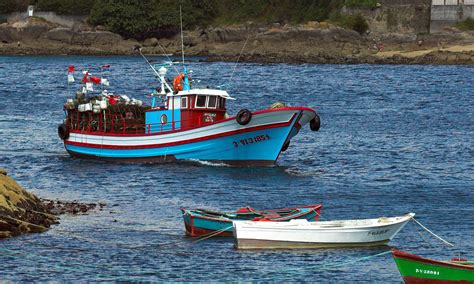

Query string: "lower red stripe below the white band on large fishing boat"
[[64, 118, 293, 150]]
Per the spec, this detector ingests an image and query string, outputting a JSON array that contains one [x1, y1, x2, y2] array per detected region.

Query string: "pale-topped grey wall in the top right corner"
[[430, 0, 474, 33]]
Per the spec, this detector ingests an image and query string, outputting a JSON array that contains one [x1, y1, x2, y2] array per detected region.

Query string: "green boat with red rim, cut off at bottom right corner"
[[392, 249, 474, 283]]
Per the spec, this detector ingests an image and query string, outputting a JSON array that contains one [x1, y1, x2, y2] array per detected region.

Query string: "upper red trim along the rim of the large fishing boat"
[[65, 107, 316, 137]]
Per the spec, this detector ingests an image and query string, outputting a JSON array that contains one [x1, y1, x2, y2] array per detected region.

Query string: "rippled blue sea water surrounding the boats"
[[0, 56, 474, 282]]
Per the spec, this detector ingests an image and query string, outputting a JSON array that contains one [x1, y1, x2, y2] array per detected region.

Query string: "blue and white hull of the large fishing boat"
[[65, 108, 316, 166]]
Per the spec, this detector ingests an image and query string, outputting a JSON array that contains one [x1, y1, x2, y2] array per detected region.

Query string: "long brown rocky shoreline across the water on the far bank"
[[0, 19, 474, 64]]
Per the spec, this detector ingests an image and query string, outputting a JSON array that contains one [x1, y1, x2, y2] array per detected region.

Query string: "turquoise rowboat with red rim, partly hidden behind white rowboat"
[[181, 204, 322, 236]]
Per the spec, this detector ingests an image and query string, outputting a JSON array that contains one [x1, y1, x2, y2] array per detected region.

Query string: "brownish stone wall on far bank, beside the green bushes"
[[341, 0, 431, 34]]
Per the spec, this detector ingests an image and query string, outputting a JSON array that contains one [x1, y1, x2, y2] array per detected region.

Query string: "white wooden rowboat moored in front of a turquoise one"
[[233, 213, 415, 249]]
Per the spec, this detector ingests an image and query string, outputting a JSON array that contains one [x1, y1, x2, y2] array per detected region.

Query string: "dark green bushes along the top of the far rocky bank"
[[0, 0, 377, 39]]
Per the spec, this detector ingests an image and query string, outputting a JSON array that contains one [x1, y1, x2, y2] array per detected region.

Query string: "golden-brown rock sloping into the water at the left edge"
[[0, 169, 57, 238]]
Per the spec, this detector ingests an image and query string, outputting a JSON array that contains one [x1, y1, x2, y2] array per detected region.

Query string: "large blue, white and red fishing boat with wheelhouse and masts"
[[58, 48, 320, 166]]
